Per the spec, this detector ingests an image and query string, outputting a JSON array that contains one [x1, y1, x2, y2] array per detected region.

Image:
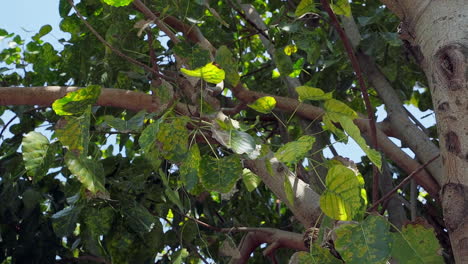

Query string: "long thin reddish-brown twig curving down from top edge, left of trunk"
[[320, 0, 379, 203]]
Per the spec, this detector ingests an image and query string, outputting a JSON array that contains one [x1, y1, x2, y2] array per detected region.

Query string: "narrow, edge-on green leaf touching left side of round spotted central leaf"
[[180, 144, 201, 191]]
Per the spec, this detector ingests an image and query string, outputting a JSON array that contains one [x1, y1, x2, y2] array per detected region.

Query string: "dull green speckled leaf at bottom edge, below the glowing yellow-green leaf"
[[335, 215, 392, 264]]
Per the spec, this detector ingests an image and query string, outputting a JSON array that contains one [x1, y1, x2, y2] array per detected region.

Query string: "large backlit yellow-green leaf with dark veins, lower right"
[[320, 165, 362, 221]]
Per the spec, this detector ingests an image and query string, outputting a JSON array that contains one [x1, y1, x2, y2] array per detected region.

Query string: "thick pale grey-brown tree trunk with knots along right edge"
[[382, 0, 468, 263]]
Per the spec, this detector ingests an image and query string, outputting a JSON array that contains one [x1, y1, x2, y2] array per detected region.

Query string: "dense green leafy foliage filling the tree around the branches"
[[0, 0, 443, 263]]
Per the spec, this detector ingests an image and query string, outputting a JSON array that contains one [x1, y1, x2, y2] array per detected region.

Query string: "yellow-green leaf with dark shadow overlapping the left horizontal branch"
[[52, 85, 101, 116]]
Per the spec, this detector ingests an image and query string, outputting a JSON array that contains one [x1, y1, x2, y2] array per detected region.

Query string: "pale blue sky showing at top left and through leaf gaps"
[[0, 0, 435, 162]]
